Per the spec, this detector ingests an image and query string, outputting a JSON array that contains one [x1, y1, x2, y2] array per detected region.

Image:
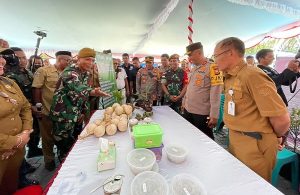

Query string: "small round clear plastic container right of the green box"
[[166, 144, 188, 164]]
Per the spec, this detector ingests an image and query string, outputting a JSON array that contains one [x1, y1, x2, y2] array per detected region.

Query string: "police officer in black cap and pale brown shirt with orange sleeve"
[[183, 42, 223, 139]]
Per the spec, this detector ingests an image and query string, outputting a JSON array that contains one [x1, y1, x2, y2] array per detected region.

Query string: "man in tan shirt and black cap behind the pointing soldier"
[[32, 51, 72, 171]]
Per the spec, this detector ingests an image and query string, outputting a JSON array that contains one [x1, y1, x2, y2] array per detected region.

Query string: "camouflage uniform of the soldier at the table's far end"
[[161, 68, 187, 113]]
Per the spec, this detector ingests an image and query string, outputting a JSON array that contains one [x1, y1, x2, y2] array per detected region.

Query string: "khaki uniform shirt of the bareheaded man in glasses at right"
[[224, 61, 287, 133]]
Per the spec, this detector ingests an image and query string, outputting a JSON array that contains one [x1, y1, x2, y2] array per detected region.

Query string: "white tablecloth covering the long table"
[[48, 106, 282, 195]]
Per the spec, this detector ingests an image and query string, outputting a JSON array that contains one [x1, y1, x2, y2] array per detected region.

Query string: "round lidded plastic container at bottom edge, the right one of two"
[[170, 174, 207, 195]]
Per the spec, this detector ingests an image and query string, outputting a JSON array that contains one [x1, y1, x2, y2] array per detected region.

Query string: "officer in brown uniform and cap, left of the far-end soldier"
[[136, 56, 161, 106]]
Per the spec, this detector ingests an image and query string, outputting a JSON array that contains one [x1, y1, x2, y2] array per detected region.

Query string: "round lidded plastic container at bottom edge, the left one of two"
[[131, 171, 169, 195]]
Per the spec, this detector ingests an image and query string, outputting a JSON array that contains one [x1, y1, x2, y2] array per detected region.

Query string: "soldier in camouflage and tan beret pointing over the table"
[[49, 48, 108, 161]]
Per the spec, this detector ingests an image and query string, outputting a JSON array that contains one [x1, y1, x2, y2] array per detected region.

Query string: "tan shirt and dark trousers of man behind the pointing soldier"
[[32, 66, 60, 163]]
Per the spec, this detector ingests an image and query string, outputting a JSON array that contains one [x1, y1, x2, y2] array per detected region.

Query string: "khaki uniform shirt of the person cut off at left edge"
[[0, 76, 32, 152]]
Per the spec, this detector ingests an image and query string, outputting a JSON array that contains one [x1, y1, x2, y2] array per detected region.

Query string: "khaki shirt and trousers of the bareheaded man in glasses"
[[224, 61, 287, 181]]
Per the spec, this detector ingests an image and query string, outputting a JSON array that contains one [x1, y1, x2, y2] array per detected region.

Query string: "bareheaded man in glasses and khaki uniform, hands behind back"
[[214, 37, 290, 181]]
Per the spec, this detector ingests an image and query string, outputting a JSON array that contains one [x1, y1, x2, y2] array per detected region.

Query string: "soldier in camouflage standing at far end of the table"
[[161, 54, 187, 114]]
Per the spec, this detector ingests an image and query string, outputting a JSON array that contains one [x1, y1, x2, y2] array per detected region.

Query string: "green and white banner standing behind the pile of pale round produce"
[[96, 52, 117, 109]]
